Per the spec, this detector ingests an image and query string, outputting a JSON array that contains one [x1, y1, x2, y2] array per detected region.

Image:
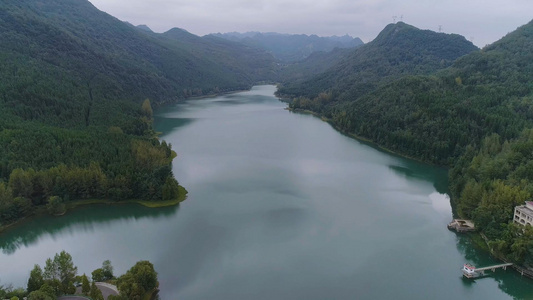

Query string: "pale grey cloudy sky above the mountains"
[[90, 0, 533, 47]]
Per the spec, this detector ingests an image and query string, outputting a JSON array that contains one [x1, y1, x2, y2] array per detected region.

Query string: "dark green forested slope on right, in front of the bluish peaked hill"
[[296, 20, 533, 165]]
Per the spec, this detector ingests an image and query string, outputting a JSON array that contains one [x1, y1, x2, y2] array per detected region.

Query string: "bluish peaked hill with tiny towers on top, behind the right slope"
[[279, 22, 477, 101]]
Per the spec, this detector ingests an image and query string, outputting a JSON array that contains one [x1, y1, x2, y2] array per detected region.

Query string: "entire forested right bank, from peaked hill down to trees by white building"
[[279, 22, 533, 266]]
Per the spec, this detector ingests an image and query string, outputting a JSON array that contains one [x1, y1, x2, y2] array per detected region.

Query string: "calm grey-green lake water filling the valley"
[[0, 86, 533, 300]]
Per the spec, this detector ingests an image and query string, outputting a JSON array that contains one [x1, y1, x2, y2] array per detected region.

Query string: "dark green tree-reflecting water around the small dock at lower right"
[[456, 234, 533, 299]]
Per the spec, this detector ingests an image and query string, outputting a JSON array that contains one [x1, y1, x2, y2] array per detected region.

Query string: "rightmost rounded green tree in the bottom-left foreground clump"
[[117, 261, 158, 299]]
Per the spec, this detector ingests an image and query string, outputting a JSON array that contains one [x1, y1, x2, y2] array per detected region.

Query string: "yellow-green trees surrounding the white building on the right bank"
[[450, 129, 533, 265]]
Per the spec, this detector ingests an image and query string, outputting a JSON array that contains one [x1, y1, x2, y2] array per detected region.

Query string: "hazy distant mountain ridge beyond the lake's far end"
[[211, 32, 363, 62]]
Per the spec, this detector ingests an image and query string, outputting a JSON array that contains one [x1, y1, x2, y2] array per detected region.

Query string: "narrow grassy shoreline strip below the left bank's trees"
[[0, 185, 189, 234]]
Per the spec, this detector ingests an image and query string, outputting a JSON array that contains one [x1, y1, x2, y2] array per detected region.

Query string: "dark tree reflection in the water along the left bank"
[[0, 204, 179, 254]]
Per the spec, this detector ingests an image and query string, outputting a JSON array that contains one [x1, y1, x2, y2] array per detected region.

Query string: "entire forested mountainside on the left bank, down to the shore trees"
[[0, 0, 277, 226]]
